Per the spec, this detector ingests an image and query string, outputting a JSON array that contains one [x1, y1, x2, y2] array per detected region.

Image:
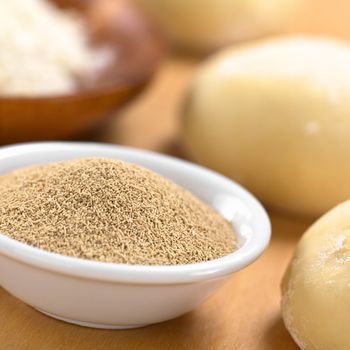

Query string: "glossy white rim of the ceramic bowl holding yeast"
[[0, 142, 271, 284]]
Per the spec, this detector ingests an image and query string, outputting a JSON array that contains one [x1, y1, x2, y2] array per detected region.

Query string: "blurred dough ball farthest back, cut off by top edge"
[[137, 0, 301, 51]]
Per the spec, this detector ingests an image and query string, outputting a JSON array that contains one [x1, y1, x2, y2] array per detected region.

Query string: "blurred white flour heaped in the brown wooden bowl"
[[0, 0, 111, 96]]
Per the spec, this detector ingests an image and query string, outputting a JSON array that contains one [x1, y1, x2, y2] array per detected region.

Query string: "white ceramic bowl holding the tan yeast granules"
[[0, 143, 270, 329]]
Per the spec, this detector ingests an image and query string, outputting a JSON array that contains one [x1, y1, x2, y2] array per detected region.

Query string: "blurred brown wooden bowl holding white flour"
[[0, 0, 164, 144]]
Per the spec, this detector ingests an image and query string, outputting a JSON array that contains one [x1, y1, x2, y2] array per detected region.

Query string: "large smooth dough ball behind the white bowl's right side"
[[184, 37, 350, 216]]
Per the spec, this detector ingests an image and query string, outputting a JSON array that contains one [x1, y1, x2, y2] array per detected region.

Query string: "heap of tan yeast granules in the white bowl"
[[0, 158, 236, 265]]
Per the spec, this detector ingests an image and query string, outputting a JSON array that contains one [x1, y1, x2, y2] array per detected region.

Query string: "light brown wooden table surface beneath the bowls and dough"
[[0, 0, 350, 350]]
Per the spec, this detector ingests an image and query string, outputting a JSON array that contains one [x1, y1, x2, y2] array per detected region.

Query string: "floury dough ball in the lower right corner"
[[282, 201, 350, 350]]
